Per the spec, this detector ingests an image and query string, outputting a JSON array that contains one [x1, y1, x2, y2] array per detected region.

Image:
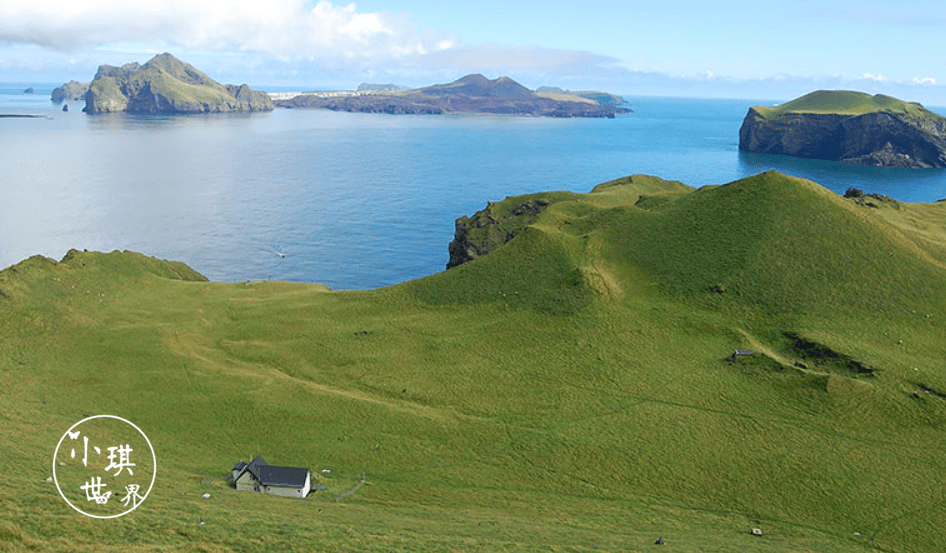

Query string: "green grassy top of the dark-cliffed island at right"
[[753, 90, 938, 119]]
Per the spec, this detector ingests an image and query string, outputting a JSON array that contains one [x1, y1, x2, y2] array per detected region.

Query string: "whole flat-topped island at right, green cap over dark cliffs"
[[739, 90, 946, 168]]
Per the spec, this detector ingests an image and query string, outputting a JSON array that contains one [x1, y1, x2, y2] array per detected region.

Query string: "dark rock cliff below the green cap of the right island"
[[739, 108, 946, 168]]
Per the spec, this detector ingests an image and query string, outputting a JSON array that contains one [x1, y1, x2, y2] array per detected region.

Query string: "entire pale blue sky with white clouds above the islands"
[[0, 0, 946, 106]]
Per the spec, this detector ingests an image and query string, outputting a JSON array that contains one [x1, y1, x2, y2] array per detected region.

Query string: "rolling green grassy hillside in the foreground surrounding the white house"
[[0, 172, 946, 552]]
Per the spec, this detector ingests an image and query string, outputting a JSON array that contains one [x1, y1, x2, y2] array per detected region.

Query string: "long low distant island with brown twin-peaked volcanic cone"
[[274, 74, 631, 118]]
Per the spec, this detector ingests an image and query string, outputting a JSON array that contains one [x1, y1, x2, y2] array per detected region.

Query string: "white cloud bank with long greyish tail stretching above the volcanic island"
[[0, 0, 636, 82]]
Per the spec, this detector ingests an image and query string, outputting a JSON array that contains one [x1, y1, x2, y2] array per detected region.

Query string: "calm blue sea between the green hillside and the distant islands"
[[0, 83, 946, 289]]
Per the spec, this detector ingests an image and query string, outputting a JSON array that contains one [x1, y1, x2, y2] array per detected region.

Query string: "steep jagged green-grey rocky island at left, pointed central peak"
[[83, 53, 273, 113]]
